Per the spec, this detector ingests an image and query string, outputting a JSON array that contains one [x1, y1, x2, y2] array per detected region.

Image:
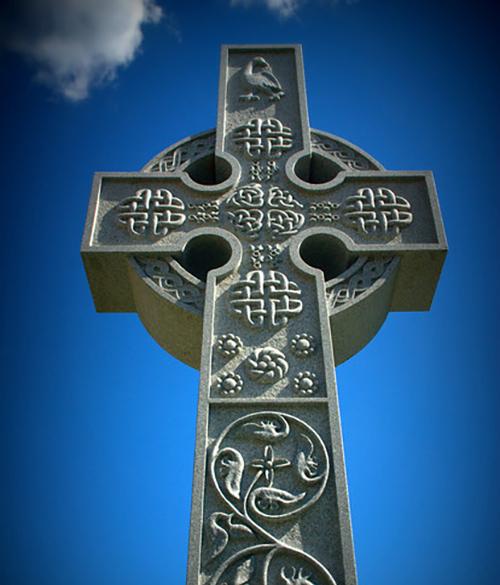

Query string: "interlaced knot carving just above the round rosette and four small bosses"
[[230, 270, 302, 327]]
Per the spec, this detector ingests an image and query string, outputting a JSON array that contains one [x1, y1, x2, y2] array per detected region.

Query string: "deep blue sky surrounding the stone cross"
[[0, 0, 500, 585]]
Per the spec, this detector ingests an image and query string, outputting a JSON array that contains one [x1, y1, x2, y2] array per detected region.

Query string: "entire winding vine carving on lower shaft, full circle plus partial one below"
[[208, 412, 336, 585]]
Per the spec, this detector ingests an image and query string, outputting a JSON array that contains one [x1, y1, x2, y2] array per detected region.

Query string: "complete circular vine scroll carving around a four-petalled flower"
[[212, 412, 329, 526]]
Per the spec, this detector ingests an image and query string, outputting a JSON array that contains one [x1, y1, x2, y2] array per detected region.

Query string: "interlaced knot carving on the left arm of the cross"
[[118, 189, 186, 236]]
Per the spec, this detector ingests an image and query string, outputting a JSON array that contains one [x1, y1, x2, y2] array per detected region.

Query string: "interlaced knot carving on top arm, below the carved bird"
[[234, 118, 293, 159]]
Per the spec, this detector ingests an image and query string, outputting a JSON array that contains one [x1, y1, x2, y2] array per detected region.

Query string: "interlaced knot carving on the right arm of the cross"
[[342, 187, 413, 236]]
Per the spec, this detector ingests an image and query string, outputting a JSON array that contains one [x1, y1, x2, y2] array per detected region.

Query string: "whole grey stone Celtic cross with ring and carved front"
[[82, 46, 446, 585]]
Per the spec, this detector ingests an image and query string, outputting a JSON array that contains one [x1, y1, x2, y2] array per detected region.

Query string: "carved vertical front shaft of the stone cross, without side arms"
[[188, 47, 356, 585]]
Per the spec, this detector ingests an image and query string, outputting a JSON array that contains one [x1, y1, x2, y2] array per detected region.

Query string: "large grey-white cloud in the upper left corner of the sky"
[[0, 0, 164, 101]]
